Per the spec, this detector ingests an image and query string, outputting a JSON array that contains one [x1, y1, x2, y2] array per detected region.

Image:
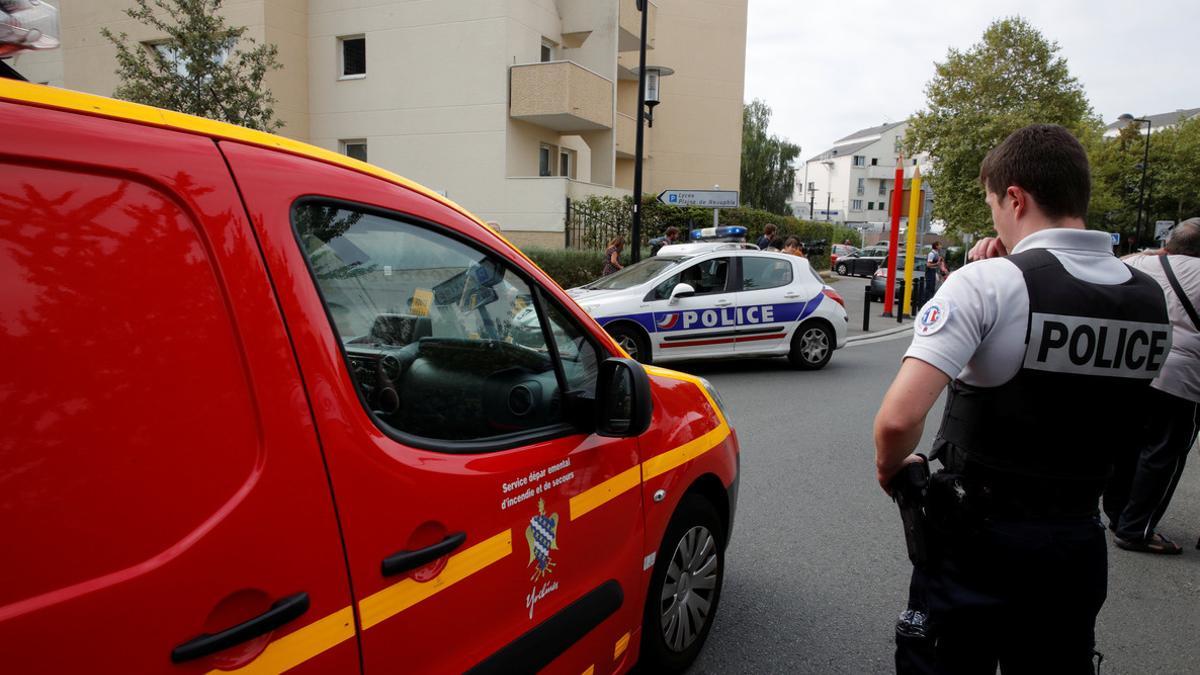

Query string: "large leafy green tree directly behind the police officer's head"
[[905, 17, 1098, 235]]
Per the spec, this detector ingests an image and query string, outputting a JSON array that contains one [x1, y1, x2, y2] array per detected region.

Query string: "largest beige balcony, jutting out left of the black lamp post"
[[509, 61, 613, 133]]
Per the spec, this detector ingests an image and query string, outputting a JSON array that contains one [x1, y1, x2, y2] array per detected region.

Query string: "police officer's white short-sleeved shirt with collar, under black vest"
[[905, 227, 1132, 387]]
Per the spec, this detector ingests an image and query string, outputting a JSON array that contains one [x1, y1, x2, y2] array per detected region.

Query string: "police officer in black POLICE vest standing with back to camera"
[[875, 125, 1170, 674]]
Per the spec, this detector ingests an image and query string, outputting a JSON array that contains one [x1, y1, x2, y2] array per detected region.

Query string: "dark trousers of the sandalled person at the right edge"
[[1104, 389, 1200, 542]]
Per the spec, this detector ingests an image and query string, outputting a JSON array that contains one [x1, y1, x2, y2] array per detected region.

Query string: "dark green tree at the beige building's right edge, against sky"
[[742, 98, 800, 215]]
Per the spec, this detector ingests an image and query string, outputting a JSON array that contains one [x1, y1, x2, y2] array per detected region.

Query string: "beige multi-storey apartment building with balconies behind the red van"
[[12, 0, 749, 246]]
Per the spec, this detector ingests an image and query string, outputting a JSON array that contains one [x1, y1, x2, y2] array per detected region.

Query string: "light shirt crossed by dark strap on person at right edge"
[[1124, 251, 1200, 402]]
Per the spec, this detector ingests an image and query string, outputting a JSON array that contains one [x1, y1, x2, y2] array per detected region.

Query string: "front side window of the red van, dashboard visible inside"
[[293, 202, 596, 452]]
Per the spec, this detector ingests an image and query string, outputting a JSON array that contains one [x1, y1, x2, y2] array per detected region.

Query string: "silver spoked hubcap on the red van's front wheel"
[[660, 525, 720, 652]]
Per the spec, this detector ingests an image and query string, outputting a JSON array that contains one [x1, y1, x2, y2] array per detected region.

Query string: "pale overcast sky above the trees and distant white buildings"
[[745, 0, 1200, 159]]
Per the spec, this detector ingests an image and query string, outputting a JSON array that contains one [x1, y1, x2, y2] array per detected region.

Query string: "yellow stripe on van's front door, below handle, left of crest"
[[359, 530, 512, 631]]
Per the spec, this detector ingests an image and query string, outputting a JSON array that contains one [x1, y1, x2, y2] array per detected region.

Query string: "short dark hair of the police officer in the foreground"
[[979, 124, 1092, 220]]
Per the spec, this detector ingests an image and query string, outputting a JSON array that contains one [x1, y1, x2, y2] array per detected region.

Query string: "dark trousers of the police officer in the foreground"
[[895, 518, 1108, 675]]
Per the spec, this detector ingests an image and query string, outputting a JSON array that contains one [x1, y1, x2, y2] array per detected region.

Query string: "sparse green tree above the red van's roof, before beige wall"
[[100, 0, 283, 131]]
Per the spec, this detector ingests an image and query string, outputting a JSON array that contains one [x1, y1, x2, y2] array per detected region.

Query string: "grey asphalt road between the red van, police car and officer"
[[673, 333, 1200, 674]]
